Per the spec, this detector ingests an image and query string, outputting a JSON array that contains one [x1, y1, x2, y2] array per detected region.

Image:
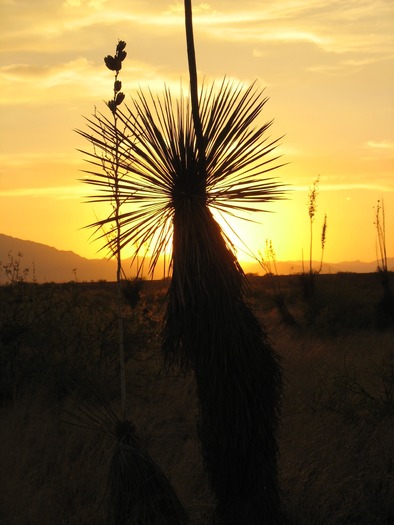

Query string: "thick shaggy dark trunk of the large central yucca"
[[163, 198, 281, 525]]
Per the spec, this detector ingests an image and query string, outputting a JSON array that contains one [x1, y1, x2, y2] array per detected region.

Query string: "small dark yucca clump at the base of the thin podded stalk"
[[66, 381, 189, 525]]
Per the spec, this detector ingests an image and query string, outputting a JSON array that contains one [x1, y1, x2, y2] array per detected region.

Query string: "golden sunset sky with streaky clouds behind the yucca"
[[0, 0, 394, 262]]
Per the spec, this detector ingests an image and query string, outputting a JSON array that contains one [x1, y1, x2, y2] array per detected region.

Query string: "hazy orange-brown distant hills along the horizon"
[[0, 234, 394, 283]]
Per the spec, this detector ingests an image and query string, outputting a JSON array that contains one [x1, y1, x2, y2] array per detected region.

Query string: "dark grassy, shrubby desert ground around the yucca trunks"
[[0, 274, 394, 525]]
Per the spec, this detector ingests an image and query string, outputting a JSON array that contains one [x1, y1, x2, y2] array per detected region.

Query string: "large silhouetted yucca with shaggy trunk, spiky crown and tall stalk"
[[80, 0, 283, 525]]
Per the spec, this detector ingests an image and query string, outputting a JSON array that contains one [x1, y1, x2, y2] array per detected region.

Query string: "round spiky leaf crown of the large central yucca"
[[78, 80, 283, 271]]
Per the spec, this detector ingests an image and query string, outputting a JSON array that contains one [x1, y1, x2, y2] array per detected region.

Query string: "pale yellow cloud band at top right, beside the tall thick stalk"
[[186, 0, 394, 56]]
